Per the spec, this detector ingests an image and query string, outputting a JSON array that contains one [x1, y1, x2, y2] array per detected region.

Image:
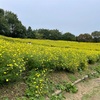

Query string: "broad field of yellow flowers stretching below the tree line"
[[0, 36, 100, 84]]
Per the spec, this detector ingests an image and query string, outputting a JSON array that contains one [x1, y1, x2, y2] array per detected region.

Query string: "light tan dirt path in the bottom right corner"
[[65, 78, 100, 100]]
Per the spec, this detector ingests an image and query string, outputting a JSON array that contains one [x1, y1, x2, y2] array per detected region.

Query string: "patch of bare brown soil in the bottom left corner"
[[0, 82, 26, 100]]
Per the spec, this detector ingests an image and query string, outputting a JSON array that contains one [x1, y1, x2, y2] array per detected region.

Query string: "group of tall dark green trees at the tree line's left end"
[[0, 9, 26, 38]]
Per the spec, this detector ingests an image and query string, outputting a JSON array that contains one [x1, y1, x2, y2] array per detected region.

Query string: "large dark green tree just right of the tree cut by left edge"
[[5, 11, 26, 37]]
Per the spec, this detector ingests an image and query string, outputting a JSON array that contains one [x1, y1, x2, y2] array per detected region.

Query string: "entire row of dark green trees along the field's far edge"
[[0, 9, 100, 42]]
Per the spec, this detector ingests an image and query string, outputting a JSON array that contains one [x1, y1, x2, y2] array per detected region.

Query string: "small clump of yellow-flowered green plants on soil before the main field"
[[26, 69, 48, 100]]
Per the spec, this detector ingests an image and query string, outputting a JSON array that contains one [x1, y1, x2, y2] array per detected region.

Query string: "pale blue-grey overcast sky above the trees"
[[0, 0, 100, 35]]
